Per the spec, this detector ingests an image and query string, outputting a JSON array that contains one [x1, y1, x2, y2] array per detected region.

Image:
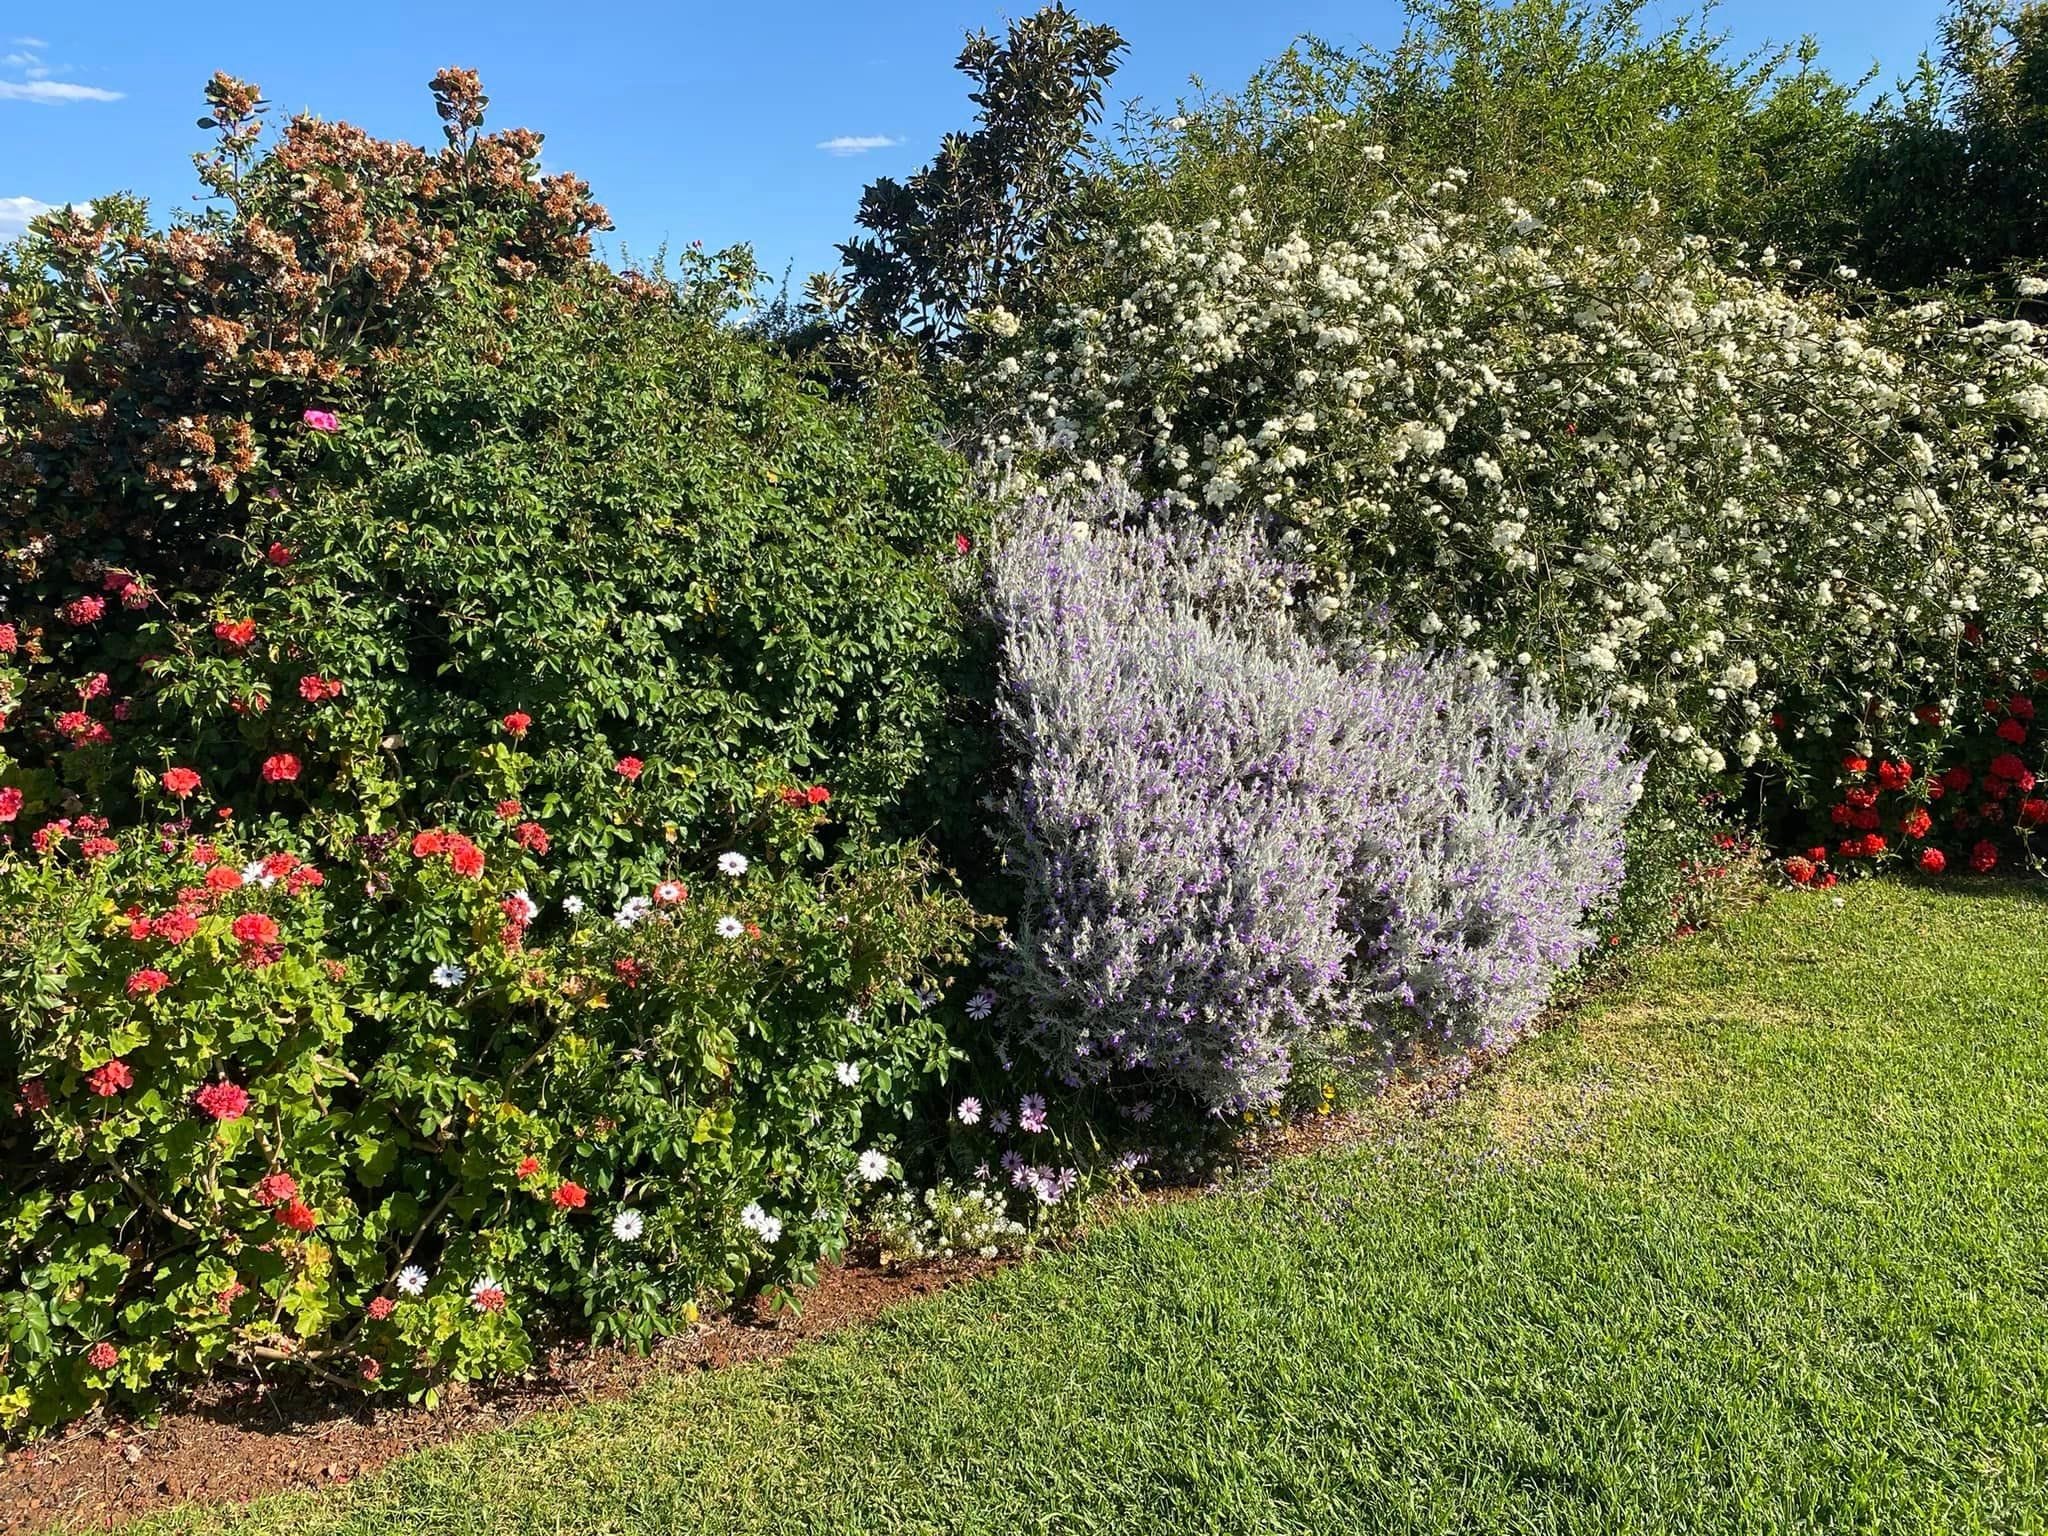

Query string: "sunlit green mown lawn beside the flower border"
[[145, 885, 2048, 1536]]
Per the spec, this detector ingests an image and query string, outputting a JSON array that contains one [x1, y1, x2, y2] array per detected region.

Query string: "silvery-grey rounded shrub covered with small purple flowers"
[[991, 492, 1640, 1116]]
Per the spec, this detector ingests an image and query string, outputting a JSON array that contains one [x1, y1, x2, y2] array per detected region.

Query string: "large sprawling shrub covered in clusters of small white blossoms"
[[967, 172, 2048, 772]]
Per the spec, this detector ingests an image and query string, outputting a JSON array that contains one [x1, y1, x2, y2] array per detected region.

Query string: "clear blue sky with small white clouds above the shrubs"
[[0, 0, 1939, 279]]
